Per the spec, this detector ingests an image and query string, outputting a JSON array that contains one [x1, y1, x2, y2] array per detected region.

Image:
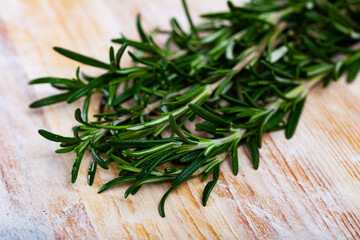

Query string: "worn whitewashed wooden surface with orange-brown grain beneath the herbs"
[[0, 0, 360, 239]]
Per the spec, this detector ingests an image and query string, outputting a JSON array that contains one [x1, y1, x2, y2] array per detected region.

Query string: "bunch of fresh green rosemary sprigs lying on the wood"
[[30, 0, 360, 217]]
